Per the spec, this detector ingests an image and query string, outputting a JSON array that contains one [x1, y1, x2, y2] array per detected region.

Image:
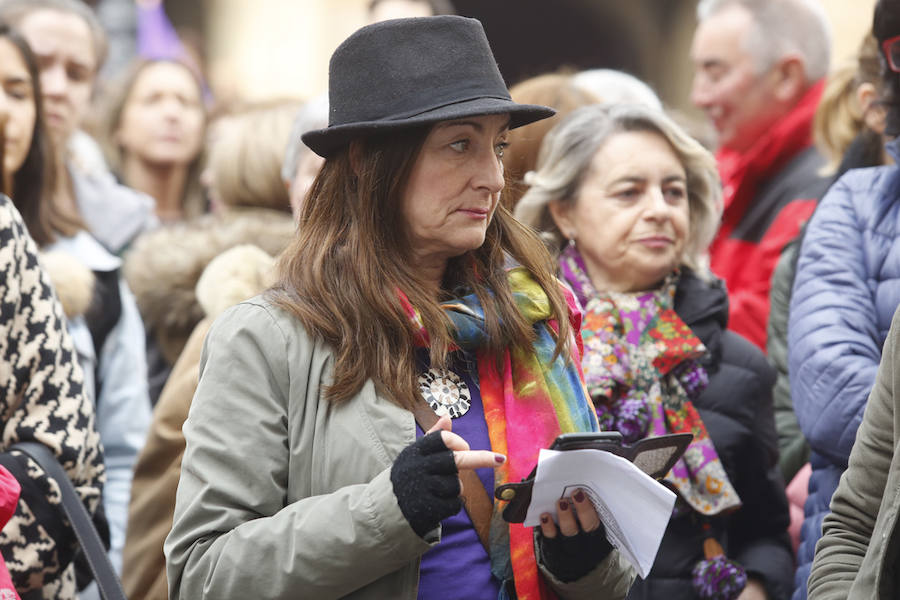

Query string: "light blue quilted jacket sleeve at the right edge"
[[788, 170, 888, 466]]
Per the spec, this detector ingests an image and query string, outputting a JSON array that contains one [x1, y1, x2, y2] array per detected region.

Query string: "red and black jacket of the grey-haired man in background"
[[709, 82, 827, 352]]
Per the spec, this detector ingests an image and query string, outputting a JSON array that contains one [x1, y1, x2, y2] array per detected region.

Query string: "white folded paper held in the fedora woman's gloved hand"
[[524, 450, 675, 578]]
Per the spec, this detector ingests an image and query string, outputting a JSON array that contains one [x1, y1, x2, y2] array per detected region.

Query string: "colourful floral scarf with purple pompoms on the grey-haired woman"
[[560, 245, 741, 515]]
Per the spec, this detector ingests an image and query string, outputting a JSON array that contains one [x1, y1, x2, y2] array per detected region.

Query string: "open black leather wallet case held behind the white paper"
[[494, 433, 694, 523]]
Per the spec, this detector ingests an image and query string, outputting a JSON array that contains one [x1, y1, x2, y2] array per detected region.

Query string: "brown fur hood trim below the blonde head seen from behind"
[[123, 209, 296, 364]]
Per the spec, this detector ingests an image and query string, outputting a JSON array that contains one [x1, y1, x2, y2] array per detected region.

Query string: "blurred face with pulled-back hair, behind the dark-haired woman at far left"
[[19, 9, 97, 150]]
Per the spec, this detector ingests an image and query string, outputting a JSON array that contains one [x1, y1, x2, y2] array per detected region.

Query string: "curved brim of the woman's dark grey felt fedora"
[[301, 98, 556, 158]]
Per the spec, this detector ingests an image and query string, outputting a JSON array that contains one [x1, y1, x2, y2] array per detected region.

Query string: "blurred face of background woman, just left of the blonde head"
[[115, 62, 206, 166]]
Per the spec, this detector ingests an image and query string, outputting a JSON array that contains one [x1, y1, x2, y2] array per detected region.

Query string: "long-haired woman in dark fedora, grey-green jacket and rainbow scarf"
[[165, 16, 633, 600]]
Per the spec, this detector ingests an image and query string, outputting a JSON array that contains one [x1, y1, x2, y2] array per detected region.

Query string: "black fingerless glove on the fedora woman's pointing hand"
[[391, 431, 462, 538]]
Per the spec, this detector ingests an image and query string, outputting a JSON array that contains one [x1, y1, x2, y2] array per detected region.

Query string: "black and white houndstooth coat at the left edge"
[[0, 195, 104, 599]]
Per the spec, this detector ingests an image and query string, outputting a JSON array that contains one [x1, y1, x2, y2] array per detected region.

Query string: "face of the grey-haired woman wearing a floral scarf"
[[550, 131, 689, 292]]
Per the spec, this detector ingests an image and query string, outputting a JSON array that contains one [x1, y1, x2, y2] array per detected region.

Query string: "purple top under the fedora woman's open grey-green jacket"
[[416, 352, 500, 600]]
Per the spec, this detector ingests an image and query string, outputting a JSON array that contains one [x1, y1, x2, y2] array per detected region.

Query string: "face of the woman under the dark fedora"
[[401, 114, 509, 270]]
